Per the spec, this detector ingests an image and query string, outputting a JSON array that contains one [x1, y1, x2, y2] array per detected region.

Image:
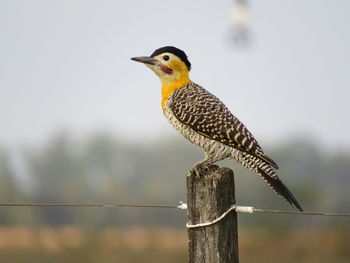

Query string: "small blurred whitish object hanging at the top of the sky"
[[230, 0, 252, 48]]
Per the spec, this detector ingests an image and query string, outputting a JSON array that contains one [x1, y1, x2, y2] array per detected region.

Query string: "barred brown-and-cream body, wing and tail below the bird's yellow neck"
[[164, 82, 301, 210]]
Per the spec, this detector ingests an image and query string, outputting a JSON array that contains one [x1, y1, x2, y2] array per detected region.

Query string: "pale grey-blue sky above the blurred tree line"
[[0, 0, 350, 149]]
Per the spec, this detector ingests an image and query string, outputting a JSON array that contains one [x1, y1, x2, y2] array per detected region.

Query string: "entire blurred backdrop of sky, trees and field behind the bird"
[[0, 0, 350, 263]]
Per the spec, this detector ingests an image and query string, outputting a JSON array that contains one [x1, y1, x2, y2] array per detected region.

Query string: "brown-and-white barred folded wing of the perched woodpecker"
[[169, 83, 278, 169]]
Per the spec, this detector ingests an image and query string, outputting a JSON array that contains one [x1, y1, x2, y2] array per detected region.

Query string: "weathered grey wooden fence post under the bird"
[[186, 165, 238, 263]]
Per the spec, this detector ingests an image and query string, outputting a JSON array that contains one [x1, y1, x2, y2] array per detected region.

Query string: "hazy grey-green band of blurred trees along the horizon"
[[0, 133, 350, 228]]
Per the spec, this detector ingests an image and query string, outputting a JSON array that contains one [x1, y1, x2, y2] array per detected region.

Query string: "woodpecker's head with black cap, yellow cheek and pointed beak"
[[131, 46, 191, 86]]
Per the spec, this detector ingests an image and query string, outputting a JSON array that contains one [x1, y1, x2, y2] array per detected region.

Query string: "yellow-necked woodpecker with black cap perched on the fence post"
[[131, 46, 303, 211]]
